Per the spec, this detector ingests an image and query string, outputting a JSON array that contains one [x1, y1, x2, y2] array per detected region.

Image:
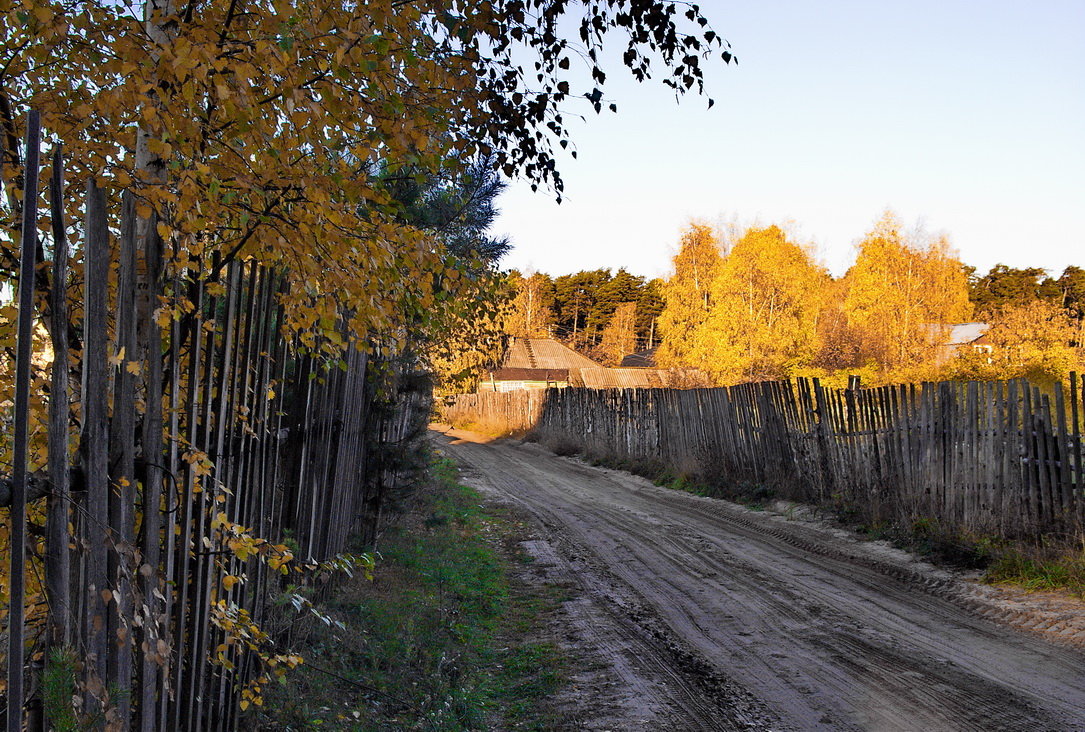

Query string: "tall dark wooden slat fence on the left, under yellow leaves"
[[0, 120, 429, 730]]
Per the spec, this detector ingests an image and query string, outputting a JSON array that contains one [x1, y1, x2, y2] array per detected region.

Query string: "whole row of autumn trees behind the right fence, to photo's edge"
[[658, 213, 1085, 383]]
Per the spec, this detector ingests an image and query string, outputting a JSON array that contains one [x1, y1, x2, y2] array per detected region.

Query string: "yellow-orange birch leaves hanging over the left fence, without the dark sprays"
[[0, 0, 478, 350]]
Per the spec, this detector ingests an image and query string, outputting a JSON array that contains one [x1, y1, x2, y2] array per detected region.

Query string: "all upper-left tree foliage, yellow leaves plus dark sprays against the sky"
[[0, 0, 730, 346]]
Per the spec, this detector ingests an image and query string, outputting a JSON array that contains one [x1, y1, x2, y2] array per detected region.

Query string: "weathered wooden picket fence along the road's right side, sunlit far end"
[[446, 374, 1085, 544]]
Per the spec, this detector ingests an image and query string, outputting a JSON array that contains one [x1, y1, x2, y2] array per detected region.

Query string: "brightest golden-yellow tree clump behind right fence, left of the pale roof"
[[659, 214, 993, 384]]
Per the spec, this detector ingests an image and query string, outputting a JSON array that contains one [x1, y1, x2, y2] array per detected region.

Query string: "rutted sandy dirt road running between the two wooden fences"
[[433, 431, 1085, 732]]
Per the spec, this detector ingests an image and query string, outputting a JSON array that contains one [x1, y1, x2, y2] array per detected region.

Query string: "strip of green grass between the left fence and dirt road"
[[250, 460, 565, 731]]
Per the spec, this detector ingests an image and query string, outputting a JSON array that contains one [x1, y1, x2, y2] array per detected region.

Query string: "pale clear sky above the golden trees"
[[494, 0, 1085, 277]]
